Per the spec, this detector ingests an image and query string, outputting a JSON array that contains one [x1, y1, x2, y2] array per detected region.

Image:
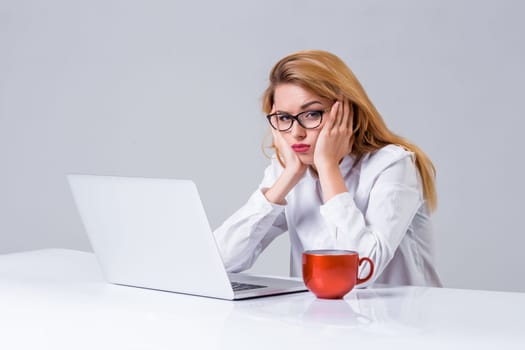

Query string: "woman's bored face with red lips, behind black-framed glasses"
[[272, 83, 332, 165]]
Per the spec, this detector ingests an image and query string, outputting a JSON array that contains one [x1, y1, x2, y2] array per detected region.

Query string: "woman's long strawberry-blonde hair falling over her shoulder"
[[262, 50, 437, 211]]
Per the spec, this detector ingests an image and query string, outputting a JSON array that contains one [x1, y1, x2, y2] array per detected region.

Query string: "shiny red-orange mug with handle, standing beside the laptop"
[[303, 249, 374, 299]]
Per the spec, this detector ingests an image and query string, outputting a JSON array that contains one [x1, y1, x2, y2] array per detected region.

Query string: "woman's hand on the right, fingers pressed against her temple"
[[314, 99, 354, 171]]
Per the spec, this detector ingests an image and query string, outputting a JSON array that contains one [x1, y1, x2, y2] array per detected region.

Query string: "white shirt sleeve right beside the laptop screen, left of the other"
[[214, 161, 287, 272]]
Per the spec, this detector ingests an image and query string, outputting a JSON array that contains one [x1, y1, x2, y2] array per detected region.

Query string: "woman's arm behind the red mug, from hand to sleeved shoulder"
[[314, 100, 423, 284]]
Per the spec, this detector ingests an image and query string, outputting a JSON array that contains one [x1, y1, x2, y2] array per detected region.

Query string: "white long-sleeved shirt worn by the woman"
[[214, 145, 441, 286]]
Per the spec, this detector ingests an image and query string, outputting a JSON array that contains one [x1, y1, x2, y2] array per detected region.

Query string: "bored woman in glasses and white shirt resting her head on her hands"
[[215, 51, 441, 286]]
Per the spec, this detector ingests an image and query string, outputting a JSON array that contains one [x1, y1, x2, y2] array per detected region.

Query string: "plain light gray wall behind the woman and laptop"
[[0, 0, 525, 291]]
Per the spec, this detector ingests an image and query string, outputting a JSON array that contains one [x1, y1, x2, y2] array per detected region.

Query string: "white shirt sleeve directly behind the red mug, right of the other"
[[320, 155, 424, 286]]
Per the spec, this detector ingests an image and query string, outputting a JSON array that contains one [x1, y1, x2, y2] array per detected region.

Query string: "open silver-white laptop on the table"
[[67, 174, 307, 300]]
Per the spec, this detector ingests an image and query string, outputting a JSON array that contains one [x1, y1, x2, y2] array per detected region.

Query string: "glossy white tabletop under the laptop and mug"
[[0, 249, 525, 350]]
